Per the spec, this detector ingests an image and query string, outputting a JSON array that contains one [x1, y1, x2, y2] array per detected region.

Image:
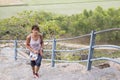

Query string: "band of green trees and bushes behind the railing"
[[0, 6, 120, 42]]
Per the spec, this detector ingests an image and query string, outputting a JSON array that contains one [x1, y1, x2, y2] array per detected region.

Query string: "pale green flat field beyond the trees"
[[0, 0, 120, 19]]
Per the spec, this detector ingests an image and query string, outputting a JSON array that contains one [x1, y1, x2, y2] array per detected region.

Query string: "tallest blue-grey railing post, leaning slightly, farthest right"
[[87, 31, 96, 70]]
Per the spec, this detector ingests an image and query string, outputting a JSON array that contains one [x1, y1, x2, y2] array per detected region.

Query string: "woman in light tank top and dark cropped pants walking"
[[26, 25, 43, 78]]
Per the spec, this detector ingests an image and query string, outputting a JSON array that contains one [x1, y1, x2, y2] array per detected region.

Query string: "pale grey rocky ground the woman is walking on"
[[0, 48, 120, 80]]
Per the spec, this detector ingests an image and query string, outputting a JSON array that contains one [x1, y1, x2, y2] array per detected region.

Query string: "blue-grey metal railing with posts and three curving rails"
[[0, 28, 120, 70]]
